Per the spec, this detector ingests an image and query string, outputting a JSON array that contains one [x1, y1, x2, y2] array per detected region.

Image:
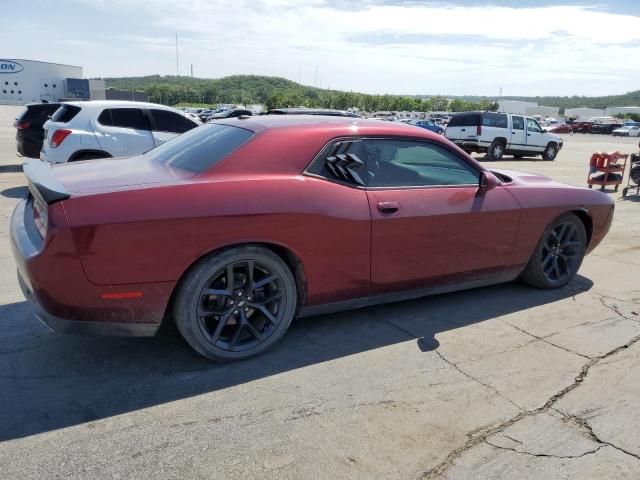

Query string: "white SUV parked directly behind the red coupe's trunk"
[[40, 100, 201, 163]]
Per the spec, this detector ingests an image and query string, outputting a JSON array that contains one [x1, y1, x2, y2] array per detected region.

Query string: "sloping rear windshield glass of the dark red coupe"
[[145, 123, 253, 173]]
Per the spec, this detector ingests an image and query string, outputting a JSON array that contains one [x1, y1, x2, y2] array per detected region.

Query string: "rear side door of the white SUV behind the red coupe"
[[94, 107, 155, 157]]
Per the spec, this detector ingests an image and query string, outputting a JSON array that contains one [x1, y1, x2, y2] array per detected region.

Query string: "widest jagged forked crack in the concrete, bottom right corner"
[[420, 335, 640, 480]]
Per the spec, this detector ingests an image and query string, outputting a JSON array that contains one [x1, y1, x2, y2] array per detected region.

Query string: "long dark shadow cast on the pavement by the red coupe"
[[0, 276, 592, 441]]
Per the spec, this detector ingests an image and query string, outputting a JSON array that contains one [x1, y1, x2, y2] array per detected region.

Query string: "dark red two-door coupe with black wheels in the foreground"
[[11, 115, 613, 360]]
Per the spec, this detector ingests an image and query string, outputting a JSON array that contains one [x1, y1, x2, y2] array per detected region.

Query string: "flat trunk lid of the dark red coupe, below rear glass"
[[52, 155, 181, 195]]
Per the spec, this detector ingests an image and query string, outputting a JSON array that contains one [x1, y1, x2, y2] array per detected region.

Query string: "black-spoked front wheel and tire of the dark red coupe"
[[520, 213, 587, 289]]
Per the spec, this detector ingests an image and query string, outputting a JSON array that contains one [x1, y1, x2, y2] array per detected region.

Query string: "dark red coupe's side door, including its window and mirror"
[[357, 139, 520, 294]]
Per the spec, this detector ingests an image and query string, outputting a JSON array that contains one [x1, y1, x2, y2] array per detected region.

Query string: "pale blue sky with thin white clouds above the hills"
[[0, 0, 640, 97]]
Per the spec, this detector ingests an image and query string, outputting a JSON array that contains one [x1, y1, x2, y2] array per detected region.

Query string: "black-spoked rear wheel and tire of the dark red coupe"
[[173, 245, 297, 362]]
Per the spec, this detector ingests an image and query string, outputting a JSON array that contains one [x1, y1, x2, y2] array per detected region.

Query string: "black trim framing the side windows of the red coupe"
[[302, 135, 488, 191]]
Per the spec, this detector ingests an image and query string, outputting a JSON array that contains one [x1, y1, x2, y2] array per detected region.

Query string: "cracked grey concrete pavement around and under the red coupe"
[[0, 107, 640, 479]]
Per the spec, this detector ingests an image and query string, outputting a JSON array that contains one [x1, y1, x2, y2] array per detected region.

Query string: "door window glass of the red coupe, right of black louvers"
[[354, 139, 480, 187]]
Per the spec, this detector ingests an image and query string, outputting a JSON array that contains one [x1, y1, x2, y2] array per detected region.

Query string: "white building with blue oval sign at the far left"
[[0, 59, 104, 105]]
